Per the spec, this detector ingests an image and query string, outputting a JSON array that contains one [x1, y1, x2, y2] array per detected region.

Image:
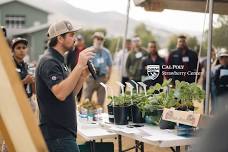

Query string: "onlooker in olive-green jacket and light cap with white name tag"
[[125, 36, 148, 86]]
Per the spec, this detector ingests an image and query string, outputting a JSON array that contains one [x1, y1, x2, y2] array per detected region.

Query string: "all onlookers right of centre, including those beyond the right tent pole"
[[115, 35, 228, 114]]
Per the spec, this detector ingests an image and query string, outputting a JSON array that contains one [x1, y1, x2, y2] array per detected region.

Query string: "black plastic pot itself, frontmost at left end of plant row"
[[113, 106, 129, 125]]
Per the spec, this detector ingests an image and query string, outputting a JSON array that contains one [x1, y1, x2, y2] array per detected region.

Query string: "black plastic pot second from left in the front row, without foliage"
[[130, 105, 145, 123]]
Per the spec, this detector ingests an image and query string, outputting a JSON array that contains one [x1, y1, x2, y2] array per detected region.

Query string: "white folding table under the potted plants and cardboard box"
[[100, 114, 196, 152]]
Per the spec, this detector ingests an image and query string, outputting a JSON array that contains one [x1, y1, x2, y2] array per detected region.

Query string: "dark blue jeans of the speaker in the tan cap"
[[46, 137, 80, 152]]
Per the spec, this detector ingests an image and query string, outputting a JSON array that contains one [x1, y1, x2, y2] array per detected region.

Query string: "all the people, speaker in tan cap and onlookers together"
[[1, 21, 228, 152]]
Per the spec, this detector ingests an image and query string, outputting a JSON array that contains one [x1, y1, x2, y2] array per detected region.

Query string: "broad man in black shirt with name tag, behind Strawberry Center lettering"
[[166, 35, 200, 84]]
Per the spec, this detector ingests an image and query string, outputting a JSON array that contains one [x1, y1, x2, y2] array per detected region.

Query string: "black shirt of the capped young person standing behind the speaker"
[[13, 58, 32, 98]]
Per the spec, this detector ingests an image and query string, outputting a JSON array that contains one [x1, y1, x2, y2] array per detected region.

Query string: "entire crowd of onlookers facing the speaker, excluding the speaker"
[[2, 22, 228, 113]]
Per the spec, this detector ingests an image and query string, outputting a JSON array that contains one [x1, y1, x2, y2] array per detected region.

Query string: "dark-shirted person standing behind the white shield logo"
[[141, 41, 165, 88]]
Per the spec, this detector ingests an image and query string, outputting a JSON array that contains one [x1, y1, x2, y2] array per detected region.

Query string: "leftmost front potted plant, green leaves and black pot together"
[[109, 95, 131, 125]]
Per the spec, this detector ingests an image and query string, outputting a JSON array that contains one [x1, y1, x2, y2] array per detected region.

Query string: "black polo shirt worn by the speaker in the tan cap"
[[36, 48, 77, 140]]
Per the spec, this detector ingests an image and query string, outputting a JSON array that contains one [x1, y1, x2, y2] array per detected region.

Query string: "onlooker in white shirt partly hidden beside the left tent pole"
[[116, 39, 132, 91]]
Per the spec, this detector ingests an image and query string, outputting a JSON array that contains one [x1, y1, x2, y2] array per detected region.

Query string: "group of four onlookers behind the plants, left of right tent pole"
[[116, 35, 201, 88]]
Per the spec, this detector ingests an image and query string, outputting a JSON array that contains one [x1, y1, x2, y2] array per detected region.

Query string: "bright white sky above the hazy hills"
[[65, 0, 217, 34]]
